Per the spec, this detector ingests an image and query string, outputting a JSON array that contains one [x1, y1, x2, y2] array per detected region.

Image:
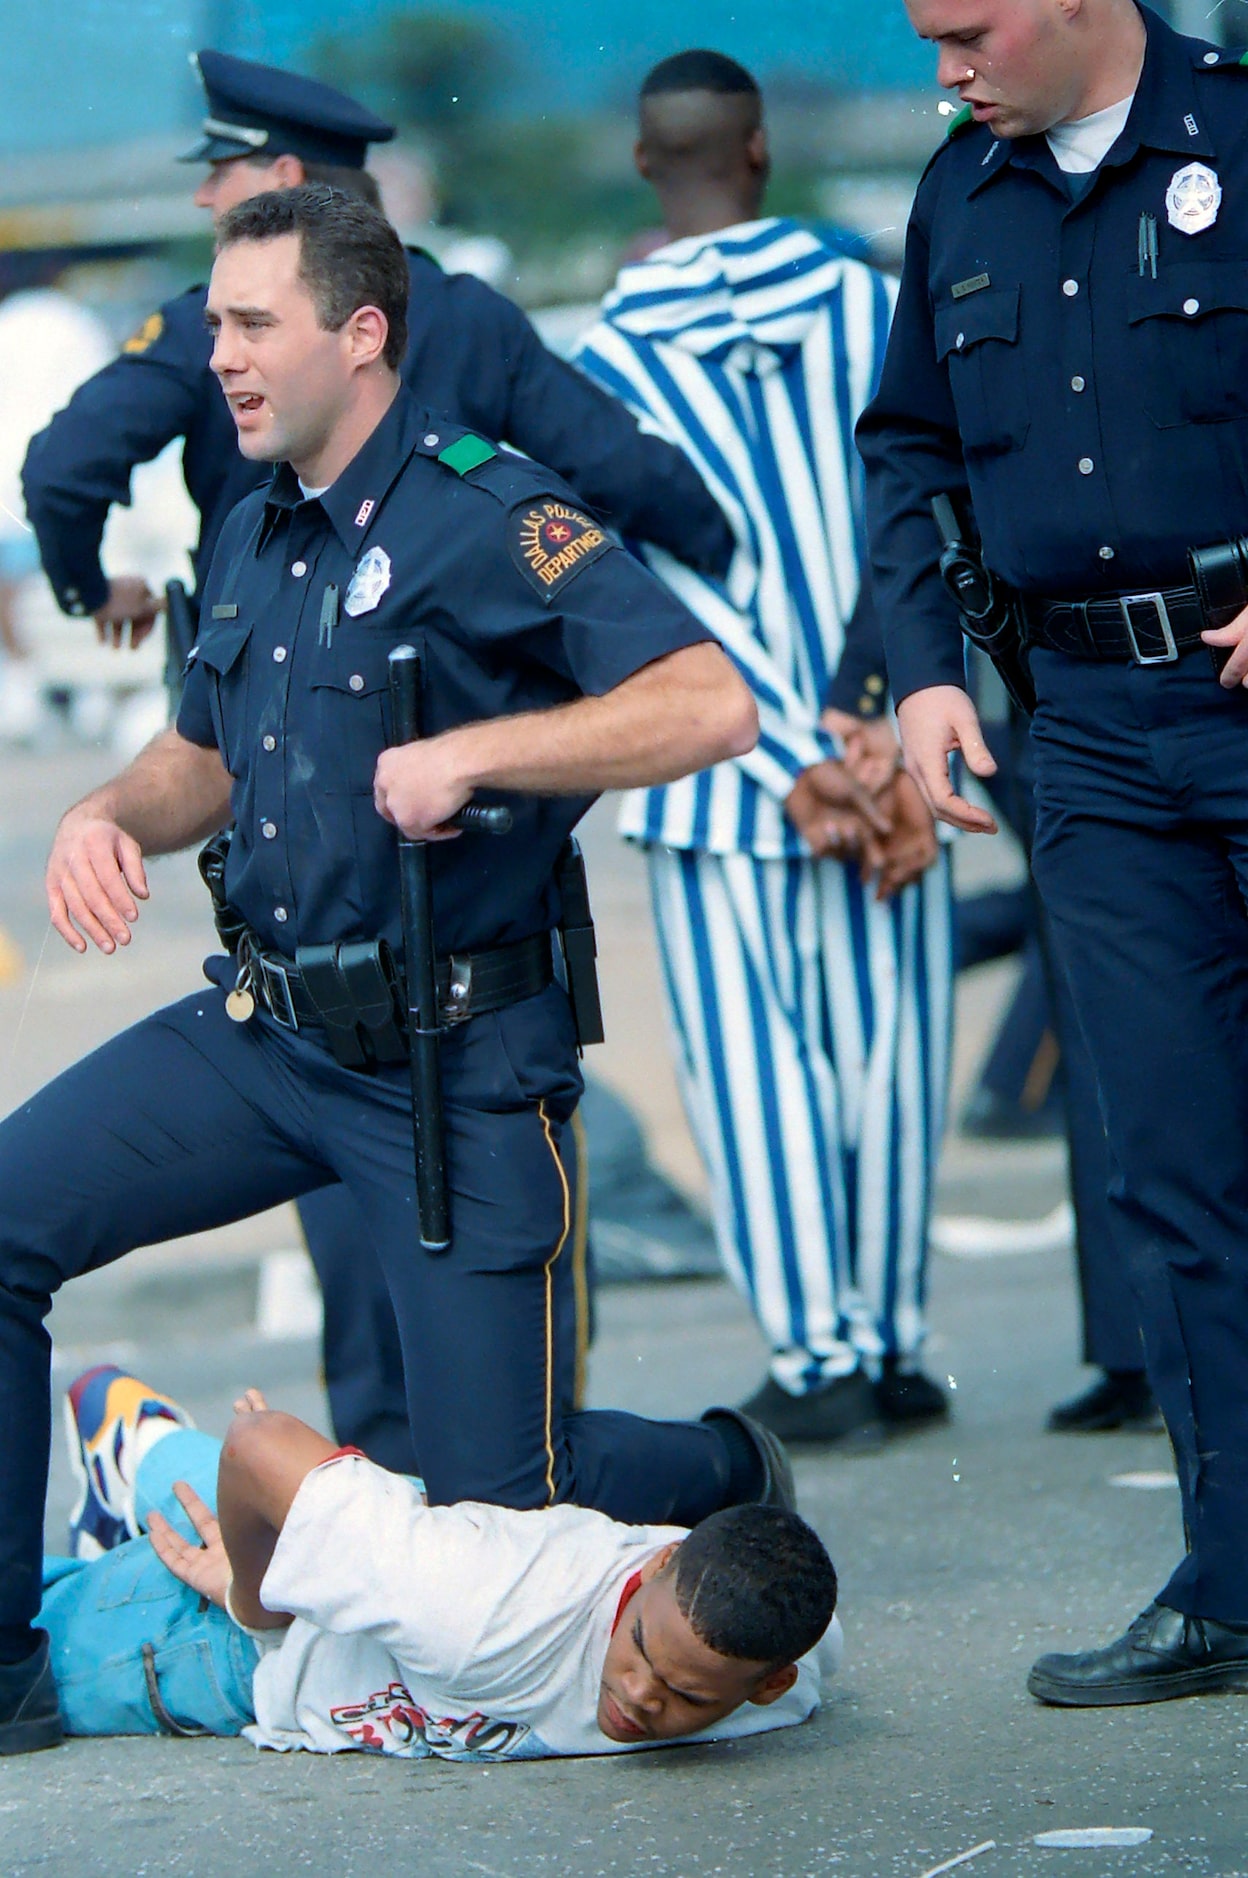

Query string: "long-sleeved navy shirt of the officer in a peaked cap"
[[23, 250, 732, 614]]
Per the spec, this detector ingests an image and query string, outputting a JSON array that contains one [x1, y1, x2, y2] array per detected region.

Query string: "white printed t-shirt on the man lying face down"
[[246, 1455, 841, 1760]]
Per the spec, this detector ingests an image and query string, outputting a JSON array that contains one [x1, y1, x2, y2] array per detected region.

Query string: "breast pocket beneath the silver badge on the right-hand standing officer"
[[1126, 259, 1248, 430]]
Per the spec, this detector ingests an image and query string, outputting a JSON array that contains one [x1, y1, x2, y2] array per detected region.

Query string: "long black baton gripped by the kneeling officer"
[[390, 646, 450, 1253]]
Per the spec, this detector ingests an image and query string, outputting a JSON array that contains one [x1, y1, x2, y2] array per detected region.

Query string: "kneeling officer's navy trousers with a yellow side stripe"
[[0, 986, 728, 1624]]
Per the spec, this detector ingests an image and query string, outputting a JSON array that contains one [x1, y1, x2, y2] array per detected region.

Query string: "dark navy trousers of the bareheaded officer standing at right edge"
[[1032, 650, 1248, 1623]]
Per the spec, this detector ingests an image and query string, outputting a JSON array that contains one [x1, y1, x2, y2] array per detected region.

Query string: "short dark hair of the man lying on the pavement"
[[672, 1504, 837, 1668]]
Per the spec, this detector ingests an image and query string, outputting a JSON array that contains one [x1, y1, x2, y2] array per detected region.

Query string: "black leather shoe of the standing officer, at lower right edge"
[[1027, 1604, 1248, 1709]]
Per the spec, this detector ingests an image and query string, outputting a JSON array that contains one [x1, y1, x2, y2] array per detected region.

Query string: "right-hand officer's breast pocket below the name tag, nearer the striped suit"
[[935, 287, 1030, 456]]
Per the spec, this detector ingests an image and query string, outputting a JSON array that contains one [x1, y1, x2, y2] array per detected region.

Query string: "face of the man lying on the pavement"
[[599, 1546, 798, 1741]]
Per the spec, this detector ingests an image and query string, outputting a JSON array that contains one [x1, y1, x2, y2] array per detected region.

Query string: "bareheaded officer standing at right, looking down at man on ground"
[[860, 0, 1248, 1705]]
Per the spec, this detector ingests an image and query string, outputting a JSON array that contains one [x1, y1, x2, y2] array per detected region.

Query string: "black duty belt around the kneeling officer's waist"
[[231, 930, 554, 1031]]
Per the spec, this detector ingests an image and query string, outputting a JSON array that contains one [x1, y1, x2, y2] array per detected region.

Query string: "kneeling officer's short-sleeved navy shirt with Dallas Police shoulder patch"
[[176, 391, 709, 956]]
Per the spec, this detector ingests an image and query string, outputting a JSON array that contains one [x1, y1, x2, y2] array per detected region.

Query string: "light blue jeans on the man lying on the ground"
[[38, 1429, 257, 1735]]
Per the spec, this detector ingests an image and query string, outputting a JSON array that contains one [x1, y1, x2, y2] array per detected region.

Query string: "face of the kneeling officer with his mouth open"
[[206, 235, 385, 470]]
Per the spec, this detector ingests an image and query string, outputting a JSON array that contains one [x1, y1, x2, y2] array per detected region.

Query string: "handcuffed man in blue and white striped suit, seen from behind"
[[580, 53, 951, 1446]]
